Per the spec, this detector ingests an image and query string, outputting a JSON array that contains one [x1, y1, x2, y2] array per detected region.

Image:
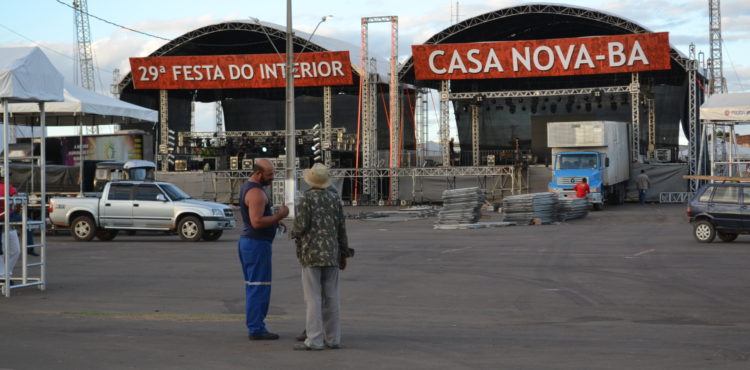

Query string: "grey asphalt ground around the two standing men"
[[0, 204, 750, 369]]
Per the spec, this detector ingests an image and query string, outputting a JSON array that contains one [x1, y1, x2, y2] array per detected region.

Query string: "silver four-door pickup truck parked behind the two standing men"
[[49, 181, 236, 242]]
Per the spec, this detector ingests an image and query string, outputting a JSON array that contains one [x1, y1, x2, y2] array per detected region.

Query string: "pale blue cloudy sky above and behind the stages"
[[0, 0, 750, 140]]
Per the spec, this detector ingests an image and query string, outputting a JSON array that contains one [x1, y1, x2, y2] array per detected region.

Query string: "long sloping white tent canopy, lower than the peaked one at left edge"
[[4, 82, 159, 126]]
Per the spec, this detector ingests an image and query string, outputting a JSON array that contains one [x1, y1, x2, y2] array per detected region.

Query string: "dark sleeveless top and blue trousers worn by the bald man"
[[238, 181, 276, 335]]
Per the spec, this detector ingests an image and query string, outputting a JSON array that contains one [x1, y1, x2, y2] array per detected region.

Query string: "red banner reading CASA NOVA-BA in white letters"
[[411, 32, 671, 80]]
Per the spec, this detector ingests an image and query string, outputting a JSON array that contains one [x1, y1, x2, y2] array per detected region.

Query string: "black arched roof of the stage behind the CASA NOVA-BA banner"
[[399, 4, 700, 92]]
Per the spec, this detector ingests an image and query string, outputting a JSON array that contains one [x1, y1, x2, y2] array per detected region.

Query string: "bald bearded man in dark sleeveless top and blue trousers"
[[239, 159, 289, 340]]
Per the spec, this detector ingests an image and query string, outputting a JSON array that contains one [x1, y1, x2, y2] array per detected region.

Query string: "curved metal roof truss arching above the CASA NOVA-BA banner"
[[401, 4, 687, 80]]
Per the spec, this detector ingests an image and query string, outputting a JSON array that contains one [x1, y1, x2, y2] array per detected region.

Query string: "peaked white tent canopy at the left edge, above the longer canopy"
[[0, 47, 63, 103]]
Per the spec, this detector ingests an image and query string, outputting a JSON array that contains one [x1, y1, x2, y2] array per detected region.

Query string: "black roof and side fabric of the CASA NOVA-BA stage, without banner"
[[399, 4, 705, 162]]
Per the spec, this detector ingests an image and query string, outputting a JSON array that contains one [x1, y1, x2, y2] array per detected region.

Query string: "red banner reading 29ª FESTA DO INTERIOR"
[[130, 51, 352, 89]]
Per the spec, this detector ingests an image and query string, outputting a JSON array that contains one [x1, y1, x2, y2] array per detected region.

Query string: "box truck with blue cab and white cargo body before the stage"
[[547, 121, 630, 210]]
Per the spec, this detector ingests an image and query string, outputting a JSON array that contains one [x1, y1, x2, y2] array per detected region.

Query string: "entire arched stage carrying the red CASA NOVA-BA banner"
[[400, 4, 705, 194]]
